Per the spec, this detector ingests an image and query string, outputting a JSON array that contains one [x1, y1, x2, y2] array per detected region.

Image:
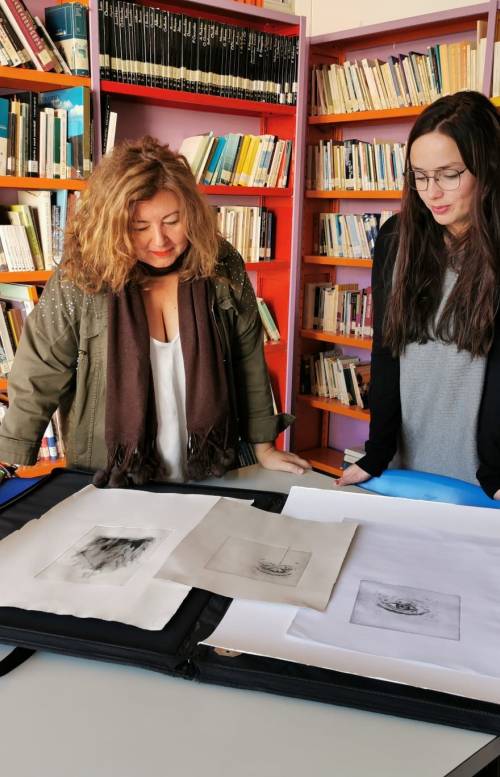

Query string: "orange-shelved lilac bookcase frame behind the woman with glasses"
[[292, 0, 500, 476]]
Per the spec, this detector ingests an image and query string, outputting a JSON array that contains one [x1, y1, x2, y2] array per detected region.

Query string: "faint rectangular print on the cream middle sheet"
[[205, 537, 312, 587]]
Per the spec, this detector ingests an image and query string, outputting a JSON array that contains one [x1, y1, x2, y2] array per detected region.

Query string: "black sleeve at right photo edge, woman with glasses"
[[476, 313, 500, 497]]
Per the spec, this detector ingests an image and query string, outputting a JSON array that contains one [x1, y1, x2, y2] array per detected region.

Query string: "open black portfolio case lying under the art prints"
[[0, 470, 500, 734]]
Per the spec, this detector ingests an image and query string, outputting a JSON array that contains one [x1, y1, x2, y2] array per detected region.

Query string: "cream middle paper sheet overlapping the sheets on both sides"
[[157, 499, 356, 609]]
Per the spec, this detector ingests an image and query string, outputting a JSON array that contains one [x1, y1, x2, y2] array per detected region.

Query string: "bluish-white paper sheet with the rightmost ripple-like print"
[[288, 523, 500, 677]]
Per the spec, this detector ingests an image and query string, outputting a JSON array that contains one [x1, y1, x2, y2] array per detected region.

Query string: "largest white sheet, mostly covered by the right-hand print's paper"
[[205, 488, 500, 704]]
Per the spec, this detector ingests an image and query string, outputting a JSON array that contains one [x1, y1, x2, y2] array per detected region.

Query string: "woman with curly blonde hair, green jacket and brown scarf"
[[0, 137, 309, 486]]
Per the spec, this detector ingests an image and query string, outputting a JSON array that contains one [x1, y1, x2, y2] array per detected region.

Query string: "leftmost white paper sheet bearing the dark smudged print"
[[0, 486, 218, 630]]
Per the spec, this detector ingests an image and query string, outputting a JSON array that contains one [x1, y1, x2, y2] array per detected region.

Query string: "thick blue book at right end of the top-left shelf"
[[45, 3, 90, 76]]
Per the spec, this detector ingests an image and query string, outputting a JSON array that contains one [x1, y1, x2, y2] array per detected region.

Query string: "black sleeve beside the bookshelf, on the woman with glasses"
[[357, 216, 401, 476]]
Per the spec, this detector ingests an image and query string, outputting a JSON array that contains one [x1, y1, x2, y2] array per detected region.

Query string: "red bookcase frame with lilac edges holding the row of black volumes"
[[89, 0, 307, 448]]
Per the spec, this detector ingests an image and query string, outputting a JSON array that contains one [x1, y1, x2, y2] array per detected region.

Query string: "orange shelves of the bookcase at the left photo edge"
[[0, 0, 91, 477]]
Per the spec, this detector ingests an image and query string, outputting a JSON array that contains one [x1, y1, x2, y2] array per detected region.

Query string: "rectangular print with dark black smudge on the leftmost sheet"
[[36, 526, 170, 585]]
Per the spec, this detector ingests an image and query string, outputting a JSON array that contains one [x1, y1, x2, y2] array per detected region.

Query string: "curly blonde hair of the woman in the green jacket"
[[63, 136, 219, 292]]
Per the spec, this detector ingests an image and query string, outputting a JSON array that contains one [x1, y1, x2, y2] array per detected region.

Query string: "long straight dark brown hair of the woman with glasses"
[[384, 92, 500, 356]]
